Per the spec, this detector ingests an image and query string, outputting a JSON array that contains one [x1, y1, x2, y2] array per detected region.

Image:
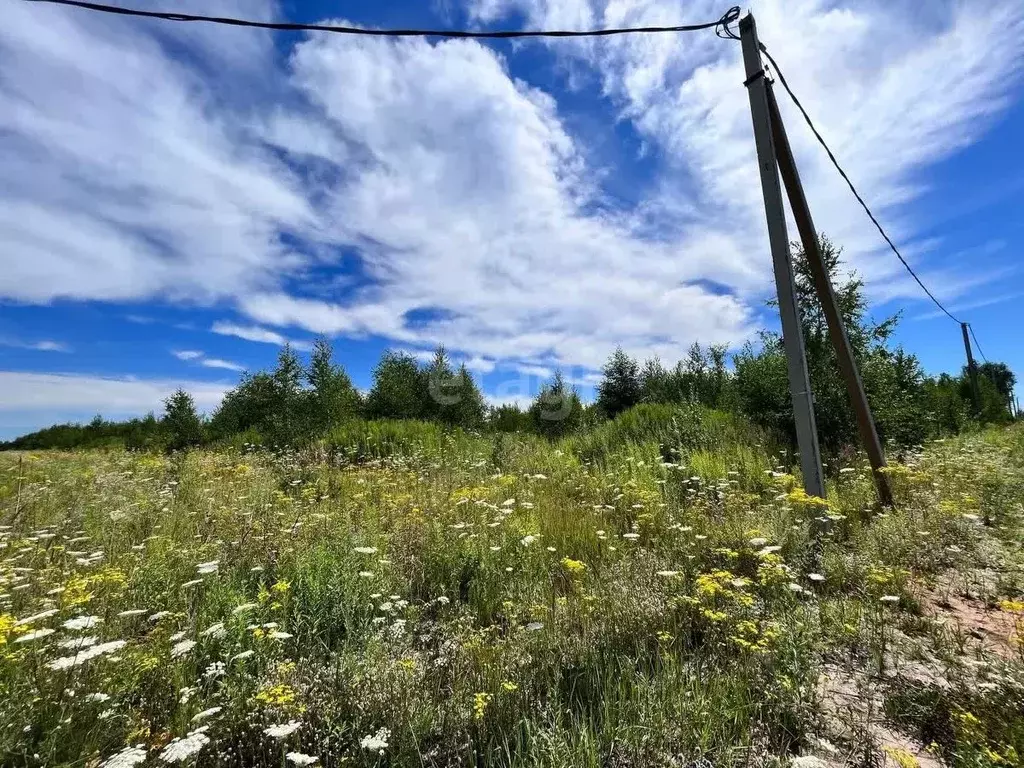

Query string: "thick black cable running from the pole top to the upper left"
[[25, 0, 739, 40]]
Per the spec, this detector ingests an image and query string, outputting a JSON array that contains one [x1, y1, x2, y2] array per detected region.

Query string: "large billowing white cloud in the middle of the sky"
[[241, 30, 750, 366]]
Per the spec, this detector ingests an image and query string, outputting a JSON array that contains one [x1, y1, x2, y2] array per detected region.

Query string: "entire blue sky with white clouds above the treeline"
[[0, 0, 1024, 437]]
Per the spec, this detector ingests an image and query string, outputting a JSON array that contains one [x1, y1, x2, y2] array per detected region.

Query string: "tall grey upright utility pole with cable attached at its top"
[[739, 13, 825, 499]]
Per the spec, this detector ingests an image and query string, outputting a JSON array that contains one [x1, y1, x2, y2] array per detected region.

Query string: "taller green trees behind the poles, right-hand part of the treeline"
[[597, 237, 1016, 451]]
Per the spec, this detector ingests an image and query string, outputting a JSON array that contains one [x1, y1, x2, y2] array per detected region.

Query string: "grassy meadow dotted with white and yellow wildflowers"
[[0, 424, 1024, 768]]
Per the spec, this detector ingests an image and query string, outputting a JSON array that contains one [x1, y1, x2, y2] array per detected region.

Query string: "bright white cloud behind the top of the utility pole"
[[472, 0, 1024, 309]]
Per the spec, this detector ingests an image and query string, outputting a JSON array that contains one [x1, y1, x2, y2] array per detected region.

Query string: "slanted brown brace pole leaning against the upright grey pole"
[[762, 83, 893, 506]]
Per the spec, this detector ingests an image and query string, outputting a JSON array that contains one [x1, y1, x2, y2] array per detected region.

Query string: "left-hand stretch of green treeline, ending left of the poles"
[[0, 339, 585, 451]]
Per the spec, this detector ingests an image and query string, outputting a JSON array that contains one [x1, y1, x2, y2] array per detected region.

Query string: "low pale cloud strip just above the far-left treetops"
[[0, 371, 228, 436]]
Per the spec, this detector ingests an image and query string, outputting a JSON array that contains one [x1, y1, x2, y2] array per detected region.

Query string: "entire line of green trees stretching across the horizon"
[[0, 238, 1016, 453]]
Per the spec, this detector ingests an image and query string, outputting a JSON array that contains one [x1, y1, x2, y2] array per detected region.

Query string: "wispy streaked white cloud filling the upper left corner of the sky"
[[0, 0, 315, 303]]
